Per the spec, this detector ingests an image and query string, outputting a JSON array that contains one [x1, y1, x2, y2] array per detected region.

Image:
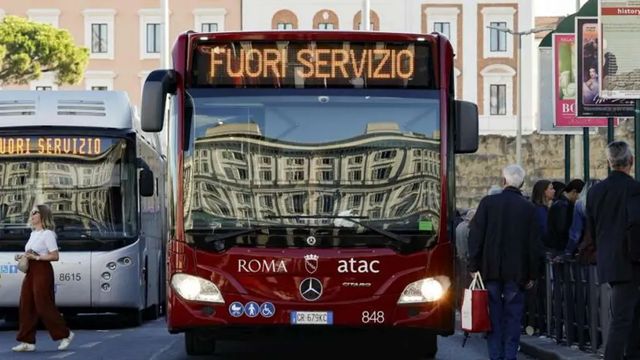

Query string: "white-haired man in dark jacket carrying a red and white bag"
[[468, 165, 541, 360]]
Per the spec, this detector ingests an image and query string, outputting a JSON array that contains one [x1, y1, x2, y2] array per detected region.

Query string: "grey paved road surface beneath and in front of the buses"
[[0, 316, 531, 360]]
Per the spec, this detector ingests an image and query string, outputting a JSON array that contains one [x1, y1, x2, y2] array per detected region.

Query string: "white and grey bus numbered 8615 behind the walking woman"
[[0, 91, 167, 325]]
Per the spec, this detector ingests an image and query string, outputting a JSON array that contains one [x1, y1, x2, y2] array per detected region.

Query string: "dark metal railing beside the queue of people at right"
[[523, 259, 609, 352]]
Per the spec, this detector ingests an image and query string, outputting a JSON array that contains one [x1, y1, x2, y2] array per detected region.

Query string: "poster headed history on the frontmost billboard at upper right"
[[598, 0, 640, 99]]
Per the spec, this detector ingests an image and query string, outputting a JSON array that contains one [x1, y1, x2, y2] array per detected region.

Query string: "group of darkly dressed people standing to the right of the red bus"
[[456, 141, 640, 360]]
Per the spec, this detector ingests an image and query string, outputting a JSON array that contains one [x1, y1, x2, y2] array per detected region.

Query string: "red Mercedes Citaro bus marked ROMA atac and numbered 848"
[[142, 31, 478, 356]]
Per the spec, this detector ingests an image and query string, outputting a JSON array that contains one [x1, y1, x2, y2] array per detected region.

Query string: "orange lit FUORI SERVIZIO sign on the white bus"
[[0, 136, 105, 156]]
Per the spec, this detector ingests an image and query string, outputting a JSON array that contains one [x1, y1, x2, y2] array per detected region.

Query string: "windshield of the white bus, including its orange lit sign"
[[0, 136, 137, 242]]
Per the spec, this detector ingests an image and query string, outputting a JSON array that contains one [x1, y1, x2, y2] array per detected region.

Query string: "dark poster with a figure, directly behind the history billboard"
[[576, 17, 635, 117]]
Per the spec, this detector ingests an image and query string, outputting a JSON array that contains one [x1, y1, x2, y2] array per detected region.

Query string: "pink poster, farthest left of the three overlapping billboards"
[[552, 34, 607, 127]]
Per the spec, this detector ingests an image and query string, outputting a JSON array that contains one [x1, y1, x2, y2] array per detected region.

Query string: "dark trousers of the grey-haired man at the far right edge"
[[604, 281, 640, 360]]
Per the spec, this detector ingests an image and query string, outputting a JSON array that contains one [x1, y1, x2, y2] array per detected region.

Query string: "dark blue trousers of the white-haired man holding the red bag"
[[487, 281, 524, 360]]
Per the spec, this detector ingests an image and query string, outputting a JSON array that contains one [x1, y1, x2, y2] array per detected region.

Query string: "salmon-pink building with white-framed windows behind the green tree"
[[0, 0, 241, 106]]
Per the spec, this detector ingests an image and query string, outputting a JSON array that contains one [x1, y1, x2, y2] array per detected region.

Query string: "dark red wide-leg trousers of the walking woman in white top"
[[16, 260, 69, 344]]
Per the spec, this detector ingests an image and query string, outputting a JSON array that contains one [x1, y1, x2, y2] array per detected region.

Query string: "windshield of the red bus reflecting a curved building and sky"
[[183, 88, 440, 249]]
